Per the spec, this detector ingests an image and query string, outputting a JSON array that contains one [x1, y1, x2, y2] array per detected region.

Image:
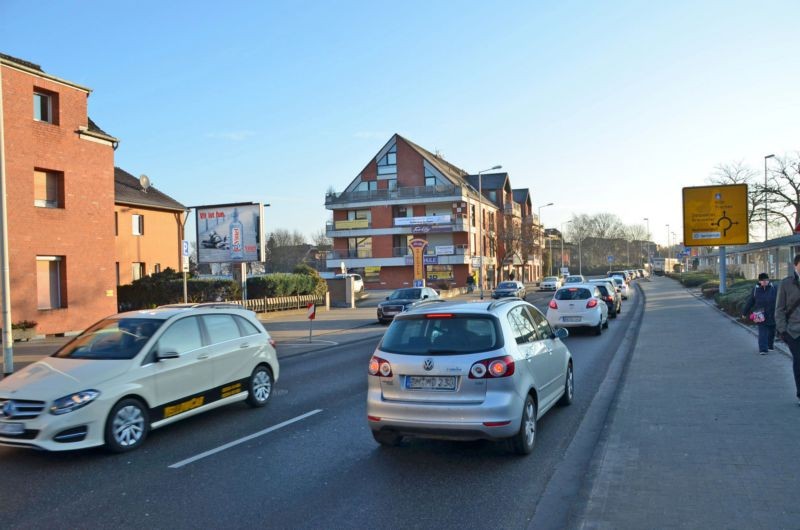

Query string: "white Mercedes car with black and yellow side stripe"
[[0, 307, 279, 452]]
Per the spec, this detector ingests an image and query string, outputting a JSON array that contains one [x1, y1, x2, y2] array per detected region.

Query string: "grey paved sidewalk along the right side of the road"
[[572, 277, 800, 529]]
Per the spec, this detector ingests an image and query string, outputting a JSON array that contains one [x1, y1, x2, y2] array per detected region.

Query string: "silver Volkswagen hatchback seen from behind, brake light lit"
[[367, 298, 574, 454]]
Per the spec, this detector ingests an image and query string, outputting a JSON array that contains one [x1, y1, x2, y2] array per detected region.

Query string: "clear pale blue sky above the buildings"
[[0, 0, 800, 244]]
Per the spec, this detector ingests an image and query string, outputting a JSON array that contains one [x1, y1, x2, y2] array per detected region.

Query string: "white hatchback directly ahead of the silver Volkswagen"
[[547, 283, 608, 335]]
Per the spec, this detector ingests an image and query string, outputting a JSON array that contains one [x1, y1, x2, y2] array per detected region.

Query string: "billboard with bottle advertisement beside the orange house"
[[195, 202, 264, 263]]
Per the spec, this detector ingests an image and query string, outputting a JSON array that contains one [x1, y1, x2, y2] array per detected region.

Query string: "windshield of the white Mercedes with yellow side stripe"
[[53, 318, 164, 359]]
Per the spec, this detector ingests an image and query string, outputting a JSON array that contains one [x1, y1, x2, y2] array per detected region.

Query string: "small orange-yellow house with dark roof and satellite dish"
[[114, 167, 187, 285]]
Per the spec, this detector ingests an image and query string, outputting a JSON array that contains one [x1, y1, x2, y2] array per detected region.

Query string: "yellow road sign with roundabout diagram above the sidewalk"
[[683, 184, 750, 247]]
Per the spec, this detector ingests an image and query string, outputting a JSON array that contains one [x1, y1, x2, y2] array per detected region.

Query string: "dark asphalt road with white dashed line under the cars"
[[0, 282, 641, 528]]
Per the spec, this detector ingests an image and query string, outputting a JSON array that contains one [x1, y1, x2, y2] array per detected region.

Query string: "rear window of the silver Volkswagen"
[[379, 314, 503, 355]]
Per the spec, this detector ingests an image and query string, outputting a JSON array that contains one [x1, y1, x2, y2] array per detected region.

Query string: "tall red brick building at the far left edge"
[[0, 54, 118, 334]]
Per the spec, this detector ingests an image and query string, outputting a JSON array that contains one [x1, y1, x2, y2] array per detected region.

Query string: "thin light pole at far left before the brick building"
[[0, 63, 14, 375]]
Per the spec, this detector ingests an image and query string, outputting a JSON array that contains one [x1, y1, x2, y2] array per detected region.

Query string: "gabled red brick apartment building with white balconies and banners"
[[325, 134, 540, 289]]
